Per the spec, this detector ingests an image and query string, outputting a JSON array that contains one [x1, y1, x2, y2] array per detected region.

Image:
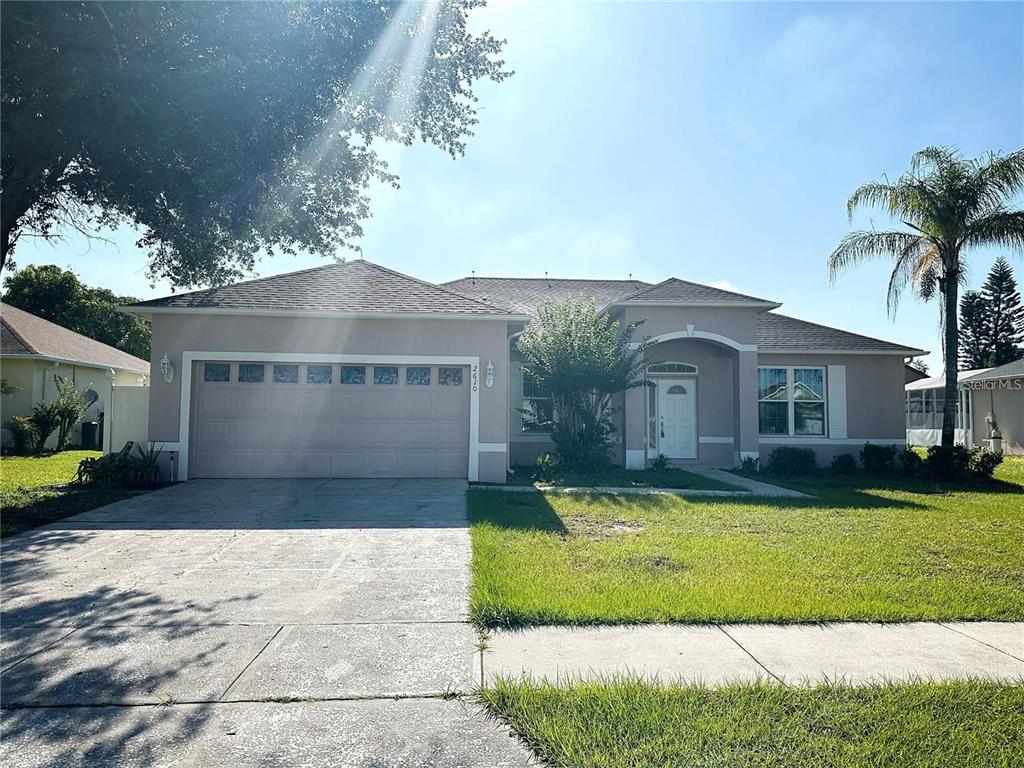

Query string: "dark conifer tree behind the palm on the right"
[[961, 256, 1024, 369]]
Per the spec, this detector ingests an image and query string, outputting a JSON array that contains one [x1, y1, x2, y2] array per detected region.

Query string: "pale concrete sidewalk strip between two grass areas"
[[481, 622, 1024, 684]]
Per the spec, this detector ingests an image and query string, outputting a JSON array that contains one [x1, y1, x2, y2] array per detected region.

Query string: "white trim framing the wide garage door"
[[174, 350, 481, 482]]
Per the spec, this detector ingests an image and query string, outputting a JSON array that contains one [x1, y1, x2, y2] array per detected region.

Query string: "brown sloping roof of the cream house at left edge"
[[0, 304, 150, 373]]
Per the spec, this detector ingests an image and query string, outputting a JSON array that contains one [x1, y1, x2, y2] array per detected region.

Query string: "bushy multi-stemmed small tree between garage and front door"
[[516, 297, 650, 470]]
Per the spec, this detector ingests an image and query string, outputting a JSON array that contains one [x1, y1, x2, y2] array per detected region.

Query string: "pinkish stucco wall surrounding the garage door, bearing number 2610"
[[150, 314, 508, 482]]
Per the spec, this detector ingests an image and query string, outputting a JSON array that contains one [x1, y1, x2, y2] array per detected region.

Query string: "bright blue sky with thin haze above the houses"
[[9, 1, 1024, 369]]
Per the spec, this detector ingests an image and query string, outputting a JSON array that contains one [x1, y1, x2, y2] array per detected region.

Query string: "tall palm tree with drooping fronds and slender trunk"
[[828, 146, 1024, 465]]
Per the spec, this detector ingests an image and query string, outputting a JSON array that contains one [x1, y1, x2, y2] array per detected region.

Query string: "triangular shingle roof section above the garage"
[[134, 259, 520, 315]]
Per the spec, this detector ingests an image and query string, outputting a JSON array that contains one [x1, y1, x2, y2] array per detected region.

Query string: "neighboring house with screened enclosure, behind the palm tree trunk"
[[906, 360, 1024, 456]]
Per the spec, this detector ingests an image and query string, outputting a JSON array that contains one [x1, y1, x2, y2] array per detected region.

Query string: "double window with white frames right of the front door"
[[758, 367, 825, 437]]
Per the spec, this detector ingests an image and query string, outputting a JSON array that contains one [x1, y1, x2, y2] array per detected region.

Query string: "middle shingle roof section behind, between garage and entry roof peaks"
[[442, 278, 650, 317]]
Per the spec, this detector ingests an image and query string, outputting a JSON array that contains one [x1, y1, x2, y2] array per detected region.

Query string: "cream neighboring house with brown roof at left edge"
[[0, 304, 150, 451]]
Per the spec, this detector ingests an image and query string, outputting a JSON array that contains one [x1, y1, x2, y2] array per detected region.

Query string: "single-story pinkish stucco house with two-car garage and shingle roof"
[[127, 260, 924, 482]]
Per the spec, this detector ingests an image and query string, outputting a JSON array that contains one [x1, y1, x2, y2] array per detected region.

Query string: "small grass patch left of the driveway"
[[0, 451, 138, 538]]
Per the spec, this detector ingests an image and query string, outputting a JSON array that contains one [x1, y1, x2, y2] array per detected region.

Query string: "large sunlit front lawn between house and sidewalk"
[[469, 459, 1024, 626]]
